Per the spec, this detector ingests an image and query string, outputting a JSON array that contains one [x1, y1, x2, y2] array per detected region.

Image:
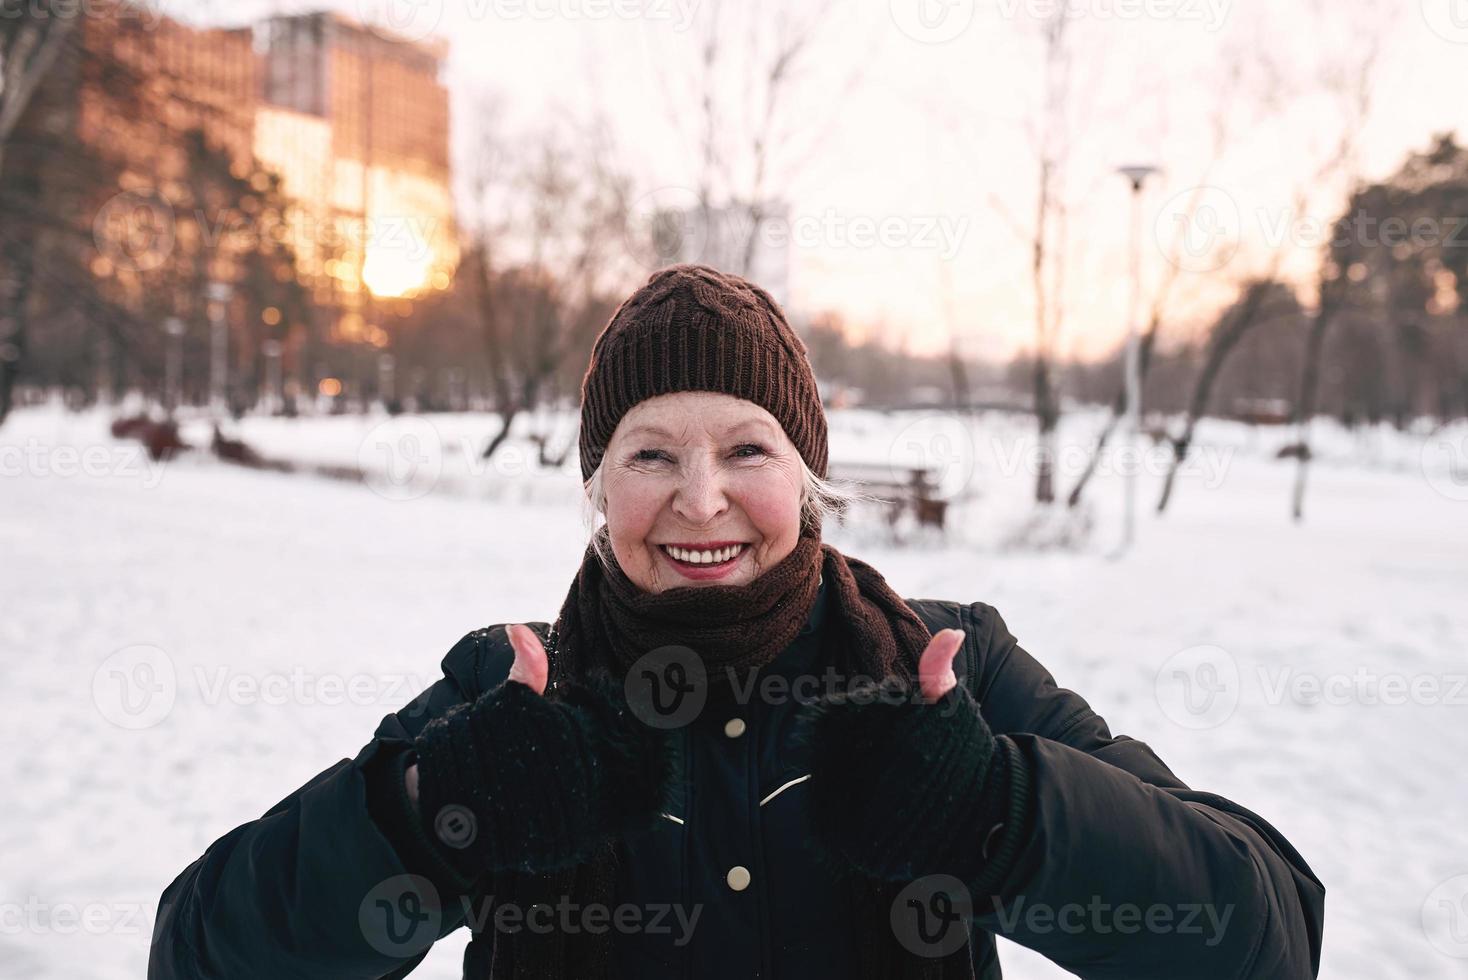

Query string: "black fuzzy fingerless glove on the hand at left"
[[414, 679, 671, 873]]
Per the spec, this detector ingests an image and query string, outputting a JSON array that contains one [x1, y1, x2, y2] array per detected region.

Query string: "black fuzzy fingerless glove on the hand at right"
[[800, 678, 1029, 891]]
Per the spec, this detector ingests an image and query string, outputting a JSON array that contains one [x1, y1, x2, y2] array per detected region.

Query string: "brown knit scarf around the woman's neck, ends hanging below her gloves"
[[481, 533, 973, 980]]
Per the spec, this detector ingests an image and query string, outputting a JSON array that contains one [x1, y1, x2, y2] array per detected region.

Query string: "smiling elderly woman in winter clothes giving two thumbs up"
[[148, 266, 1324, 980]]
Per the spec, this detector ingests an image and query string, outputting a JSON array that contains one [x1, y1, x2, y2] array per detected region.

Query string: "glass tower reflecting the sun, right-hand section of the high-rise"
[[254, 12, 458, 345]]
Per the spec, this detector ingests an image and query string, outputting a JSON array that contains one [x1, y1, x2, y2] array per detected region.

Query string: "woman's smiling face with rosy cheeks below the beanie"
[[602, 392, 803, 593]]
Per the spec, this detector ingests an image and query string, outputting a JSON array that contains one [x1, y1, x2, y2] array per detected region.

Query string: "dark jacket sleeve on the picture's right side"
[[964, 603, 1326, 980]]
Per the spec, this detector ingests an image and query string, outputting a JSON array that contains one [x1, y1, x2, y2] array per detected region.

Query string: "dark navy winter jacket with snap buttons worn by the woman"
[[148, 578, 1324, 980]]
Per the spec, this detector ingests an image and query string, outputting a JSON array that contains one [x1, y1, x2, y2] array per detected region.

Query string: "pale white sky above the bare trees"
[[174, 0, 1468, 358]]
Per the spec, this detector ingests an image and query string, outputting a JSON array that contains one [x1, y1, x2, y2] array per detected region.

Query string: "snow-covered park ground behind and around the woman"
[[0, 408, 1468, 980]]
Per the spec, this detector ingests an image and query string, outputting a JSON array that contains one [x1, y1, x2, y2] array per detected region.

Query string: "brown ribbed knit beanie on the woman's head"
[[580, 264, 826, 480]]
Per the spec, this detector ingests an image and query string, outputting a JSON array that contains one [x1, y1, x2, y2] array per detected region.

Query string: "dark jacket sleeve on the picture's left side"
[[148, 631, 508, 980]]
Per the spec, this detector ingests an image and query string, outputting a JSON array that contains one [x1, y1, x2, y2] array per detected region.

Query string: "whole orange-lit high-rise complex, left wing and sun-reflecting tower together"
[[65, 0, 458, 346]]
